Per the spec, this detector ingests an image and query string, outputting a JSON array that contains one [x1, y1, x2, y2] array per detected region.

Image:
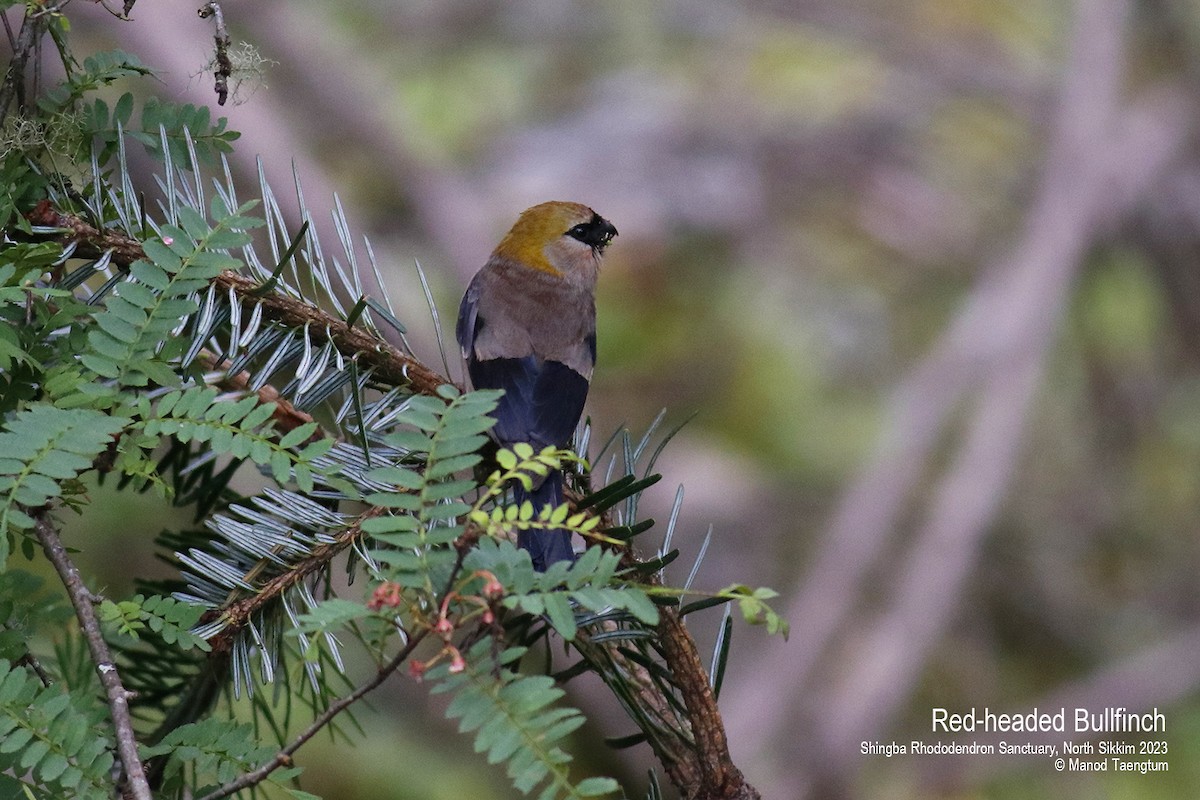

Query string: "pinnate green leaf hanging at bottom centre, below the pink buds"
[[428, 640, 617, 800]]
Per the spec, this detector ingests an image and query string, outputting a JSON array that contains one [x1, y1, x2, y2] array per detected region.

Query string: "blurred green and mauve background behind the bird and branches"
[[18, 0, 1200, 800]]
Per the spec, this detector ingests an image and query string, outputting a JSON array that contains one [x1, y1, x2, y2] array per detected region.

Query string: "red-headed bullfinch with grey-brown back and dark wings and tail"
[[455, 200, 617, 571]]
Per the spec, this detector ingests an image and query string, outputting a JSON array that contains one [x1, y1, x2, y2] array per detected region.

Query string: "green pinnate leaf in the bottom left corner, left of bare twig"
[[0, 661, 113, 800]]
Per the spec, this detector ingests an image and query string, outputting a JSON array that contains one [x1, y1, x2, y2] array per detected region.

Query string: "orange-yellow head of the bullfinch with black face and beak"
[[492, 200, 617, 282]]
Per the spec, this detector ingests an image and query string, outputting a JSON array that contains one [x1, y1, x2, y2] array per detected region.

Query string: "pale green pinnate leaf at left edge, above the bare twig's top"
[[0, 405, 131, 567]]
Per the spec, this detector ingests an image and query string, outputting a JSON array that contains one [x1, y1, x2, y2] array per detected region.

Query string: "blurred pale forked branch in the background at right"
[[730, 0, 1194, 783]]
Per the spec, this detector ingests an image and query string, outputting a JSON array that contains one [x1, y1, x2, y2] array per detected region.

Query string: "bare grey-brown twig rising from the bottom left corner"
[[36, 513, 152, 800]]
